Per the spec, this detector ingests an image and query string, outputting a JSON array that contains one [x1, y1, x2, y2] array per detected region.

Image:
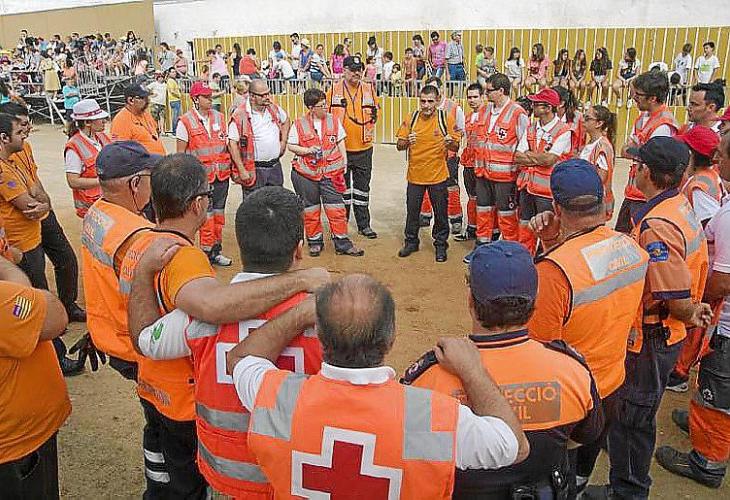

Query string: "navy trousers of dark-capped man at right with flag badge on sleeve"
[[608, 325, 682, 499]]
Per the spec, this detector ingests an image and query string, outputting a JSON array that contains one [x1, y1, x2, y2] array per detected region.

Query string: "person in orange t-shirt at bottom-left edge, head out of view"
[[0, 259, 71, 499]]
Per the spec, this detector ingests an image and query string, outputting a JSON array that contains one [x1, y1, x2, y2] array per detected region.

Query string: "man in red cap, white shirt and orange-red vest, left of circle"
[[175, 81, 231, 266]]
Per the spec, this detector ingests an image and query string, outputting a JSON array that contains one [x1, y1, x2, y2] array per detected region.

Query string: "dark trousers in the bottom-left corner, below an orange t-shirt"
[[0, 434, 59, 500]]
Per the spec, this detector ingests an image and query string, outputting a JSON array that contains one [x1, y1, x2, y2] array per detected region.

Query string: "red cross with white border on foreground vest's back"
[[291, 427, 403, 500]]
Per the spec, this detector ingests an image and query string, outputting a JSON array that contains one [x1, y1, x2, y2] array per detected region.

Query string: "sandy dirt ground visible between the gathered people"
[[21, 125, 716, 499]]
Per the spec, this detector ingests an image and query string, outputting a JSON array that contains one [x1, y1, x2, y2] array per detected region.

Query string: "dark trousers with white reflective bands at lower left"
[[139, 399, 208, 500]]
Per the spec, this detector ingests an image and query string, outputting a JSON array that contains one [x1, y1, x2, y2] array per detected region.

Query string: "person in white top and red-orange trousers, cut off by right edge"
[[655, 136, 730, 488]]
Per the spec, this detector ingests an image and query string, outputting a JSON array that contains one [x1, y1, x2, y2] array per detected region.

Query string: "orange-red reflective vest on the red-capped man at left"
[[180, 109, 231, 183]]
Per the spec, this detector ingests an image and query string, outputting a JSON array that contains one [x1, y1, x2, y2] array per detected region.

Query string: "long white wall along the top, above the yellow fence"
[[154, 0, 730, 45]]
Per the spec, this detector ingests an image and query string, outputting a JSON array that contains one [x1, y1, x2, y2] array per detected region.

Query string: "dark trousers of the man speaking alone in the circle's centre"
[[405, 181, 449, 248]]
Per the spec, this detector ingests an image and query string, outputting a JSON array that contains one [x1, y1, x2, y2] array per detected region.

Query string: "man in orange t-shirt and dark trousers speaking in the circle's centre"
[[396, 85, 461, 262]]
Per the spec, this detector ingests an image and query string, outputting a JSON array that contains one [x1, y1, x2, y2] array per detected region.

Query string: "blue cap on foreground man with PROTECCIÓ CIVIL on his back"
[[469, 240, 537, 304]]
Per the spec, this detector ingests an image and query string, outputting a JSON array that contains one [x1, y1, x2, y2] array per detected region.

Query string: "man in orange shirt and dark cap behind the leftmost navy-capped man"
[[111, 83, 167, 155]]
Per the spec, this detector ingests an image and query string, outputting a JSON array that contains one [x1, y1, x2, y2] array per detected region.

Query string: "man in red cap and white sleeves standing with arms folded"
[[515, 89, 573, 254]]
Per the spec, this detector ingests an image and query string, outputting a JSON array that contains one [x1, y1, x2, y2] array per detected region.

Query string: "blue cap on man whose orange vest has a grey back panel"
[[550, 158, 603, 209]]
